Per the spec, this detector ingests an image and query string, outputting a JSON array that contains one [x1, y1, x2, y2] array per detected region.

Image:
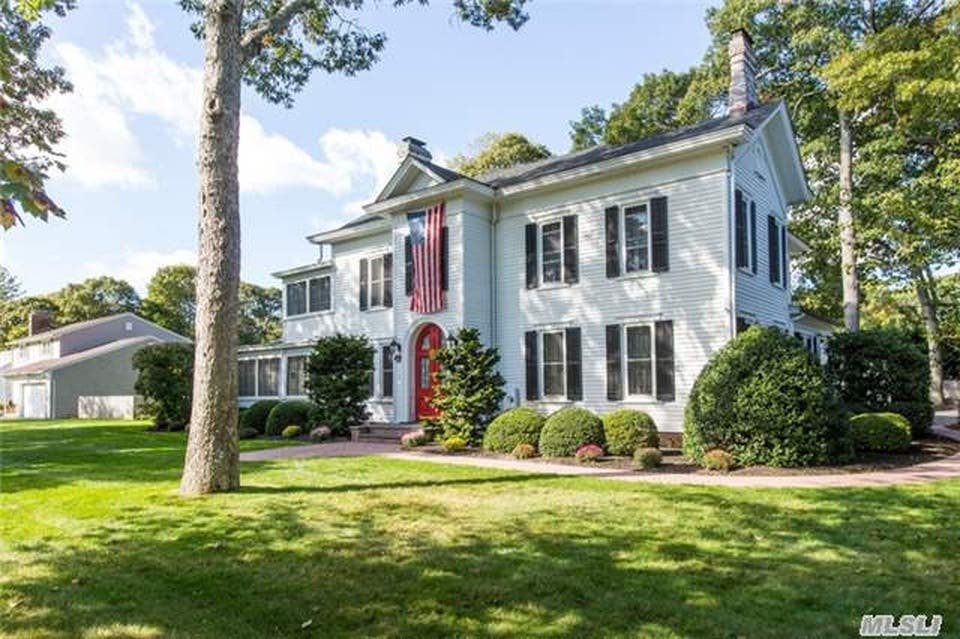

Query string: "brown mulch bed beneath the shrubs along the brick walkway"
[[415, 435, 960, 476]]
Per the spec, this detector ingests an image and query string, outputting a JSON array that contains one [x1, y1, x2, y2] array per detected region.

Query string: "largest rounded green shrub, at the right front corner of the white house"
[[683, 326, 851, 466]]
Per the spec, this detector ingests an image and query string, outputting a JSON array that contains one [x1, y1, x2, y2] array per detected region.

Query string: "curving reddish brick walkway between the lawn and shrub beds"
[[240, 412, 960, 488]]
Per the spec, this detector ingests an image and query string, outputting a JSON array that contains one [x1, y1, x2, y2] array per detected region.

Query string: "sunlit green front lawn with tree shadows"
[[0, 421, 960, 638]]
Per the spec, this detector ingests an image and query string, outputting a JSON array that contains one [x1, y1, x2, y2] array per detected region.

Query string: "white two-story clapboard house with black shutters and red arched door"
[[239, 32, 828, 432]]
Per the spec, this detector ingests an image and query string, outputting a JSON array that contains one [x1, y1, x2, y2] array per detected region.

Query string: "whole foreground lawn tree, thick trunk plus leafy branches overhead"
[[180, 0, 527, 494]]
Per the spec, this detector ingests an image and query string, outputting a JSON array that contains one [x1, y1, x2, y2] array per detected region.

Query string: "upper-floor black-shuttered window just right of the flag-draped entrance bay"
[[525, 215, 580, 288]]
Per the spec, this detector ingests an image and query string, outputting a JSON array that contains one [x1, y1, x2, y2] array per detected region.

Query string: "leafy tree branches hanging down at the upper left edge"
[[0, 0, 74, 229]]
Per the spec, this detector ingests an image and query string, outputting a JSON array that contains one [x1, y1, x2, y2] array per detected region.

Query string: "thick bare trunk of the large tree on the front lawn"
[[180, 0, 241, 495]]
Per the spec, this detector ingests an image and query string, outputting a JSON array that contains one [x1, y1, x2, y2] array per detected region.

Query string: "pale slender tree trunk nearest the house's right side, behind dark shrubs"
[[838, 111, 860, 332]]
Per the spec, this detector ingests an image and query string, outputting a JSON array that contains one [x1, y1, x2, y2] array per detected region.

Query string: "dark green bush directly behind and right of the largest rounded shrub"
[[826, 329, 933, 435]]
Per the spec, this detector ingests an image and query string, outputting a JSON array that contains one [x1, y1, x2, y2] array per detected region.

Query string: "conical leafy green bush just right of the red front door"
[[430, 328, 504, 443]]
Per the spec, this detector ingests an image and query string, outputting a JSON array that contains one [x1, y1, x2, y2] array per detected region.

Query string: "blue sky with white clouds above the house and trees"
[[7, 0, 709, 294]]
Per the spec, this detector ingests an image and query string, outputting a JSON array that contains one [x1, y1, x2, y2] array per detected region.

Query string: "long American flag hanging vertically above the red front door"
[[407, 202, 444, 313]]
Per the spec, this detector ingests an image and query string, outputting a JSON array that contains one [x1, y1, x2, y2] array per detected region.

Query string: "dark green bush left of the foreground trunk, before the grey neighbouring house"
[[133, 344, 193, 430]]
